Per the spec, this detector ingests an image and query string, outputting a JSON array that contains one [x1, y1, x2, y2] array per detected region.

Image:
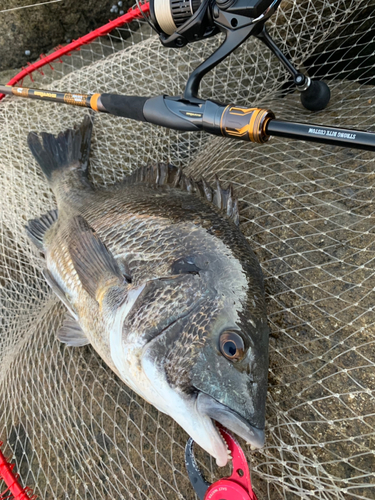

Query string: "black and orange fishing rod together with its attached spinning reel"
[[0, 0, 375, 151]]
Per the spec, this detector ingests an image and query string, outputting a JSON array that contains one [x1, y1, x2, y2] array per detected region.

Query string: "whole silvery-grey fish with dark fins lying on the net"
[[26, 115, 269, 466]]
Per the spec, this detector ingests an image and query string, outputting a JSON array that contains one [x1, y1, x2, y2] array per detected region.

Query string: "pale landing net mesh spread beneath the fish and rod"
[[0, 0, 375, 500]]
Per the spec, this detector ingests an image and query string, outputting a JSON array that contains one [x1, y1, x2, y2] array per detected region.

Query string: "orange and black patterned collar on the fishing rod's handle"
[[220, 105, 275, 144]]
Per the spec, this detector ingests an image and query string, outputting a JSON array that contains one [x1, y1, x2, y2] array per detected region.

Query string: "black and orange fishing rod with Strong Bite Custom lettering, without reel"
[[0, 85, 375, 151]]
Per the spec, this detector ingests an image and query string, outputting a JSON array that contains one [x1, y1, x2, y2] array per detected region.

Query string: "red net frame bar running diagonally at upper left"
[[0, 3, 150, 100]]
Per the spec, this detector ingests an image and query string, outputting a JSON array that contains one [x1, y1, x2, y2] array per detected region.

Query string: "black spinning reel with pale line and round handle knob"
[[145, 0, 331, 111]]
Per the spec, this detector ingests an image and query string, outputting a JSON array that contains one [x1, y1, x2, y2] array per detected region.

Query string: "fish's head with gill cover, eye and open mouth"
[[138, 262, 269, 466]]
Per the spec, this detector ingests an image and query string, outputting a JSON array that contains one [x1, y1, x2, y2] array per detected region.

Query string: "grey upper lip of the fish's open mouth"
[[196, 392, 265, 448]]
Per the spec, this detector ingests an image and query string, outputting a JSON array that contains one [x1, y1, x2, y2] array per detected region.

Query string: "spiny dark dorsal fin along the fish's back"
[[124, 163, 240, 226]]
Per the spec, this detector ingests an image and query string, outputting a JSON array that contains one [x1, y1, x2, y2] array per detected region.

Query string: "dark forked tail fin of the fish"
[[27, 115, 92, 180]]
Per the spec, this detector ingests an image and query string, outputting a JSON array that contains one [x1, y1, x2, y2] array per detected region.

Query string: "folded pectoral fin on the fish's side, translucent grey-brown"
[[69, 215, 125, 300]]
